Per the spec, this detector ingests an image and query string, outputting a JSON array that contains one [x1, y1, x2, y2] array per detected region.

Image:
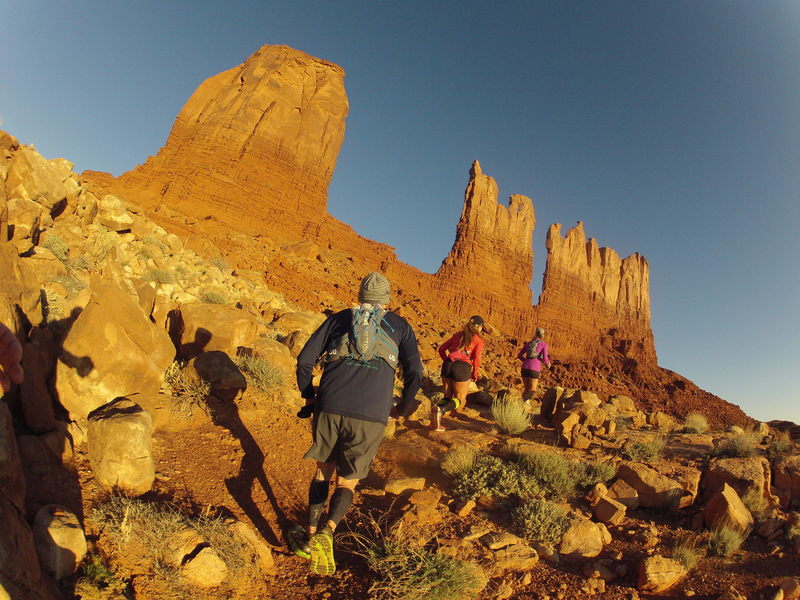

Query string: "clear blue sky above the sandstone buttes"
[[0, 0, 800, 422]]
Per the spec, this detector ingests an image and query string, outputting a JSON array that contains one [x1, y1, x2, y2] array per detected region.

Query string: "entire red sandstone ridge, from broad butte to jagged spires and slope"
[[84, 46, 746, 424]]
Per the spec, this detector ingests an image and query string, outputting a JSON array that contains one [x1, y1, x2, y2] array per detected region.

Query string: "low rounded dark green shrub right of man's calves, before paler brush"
[[453, 454, 540, 500]]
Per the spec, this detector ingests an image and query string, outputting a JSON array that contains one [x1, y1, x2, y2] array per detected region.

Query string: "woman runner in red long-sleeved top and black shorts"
[[431, 315, 484, 431]]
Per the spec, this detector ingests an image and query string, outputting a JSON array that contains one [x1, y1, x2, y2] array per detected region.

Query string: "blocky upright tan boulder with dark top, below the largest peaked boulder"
[[88, 398, 155, 495]]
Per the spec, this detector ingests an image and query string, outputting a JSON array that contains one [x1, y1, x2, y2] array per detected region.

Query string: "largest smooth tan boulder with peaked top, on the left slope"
[[56, 277, 175, 420]]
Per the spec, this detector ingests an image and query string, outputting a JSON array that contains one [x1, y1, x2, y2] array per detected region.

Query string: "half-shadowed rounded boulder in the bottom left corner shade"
[[33, 504, 86, 580]]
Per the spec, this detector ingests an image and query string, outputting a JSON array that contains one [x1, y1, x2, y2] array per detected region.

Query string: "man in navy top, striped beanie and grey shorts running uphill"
[[289, 272, 422, 575]]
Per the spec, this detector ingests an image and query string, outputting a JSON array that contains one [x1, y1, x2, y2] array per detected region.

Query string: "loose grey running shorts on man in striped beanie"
[[303, 412, 386, 479]]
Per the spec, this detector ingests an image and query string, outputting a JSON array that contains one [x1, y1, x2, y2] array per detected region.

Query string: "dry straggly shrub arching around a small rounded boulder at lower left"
[[90, 496, 258, 584]]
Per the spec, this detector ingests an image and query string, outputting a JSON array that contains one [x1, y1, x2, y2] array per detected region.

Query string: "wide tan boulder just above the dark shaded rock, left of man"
[[169, 303, 260, 359]]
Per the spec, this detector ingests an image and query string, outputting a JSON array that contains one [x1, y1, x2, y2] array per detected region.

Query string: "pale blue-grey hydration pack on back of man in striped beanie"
[[325, 304, 398, 369]]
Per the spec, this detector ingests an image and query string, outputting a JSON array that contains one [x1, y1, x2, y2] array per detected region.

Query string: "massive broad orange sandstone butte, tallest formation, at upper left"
[[88, 46, 349, 233]]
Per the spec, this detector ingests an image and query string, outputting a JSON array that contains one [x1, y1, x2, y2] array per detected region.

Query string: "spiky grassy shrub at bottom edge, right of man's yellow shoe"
[[340, 517, 487, 600]]
